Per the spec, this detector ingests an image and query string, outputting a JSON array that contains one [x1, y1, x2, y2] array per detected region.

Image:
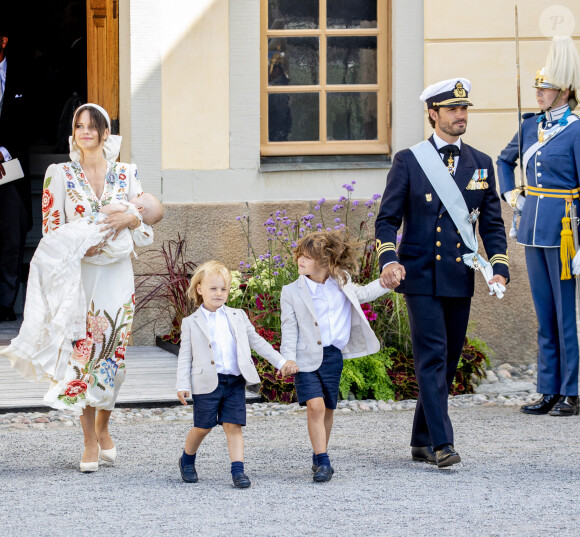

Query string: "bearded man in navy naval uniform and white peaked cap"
[[375, 78, 509, 468]]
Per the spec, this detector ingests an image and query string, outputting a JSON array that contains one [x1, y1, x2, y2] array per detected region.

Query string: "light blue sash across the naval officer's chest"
[[410, 140, 489, 270]]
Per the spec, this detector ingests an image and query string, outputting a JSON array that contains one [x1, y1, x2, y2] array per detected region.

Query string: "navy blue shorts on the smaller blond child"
[[193, 373, 246, 429]]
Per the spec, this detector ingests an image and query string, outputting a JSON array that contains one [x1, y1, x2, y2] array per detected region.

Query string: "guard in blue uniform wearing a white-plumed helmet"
[[497, 37, 580, 416]]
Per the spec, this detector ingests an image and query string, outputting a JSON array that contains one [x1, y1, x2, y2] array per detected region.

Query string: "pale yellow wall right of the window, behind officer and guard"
[[424, 0, 580, 161]]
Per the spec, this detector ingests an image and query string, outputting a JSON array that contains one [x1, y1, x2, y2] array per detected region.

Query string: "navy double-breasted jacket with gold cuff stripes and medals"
[[375, 133, 509, 297]]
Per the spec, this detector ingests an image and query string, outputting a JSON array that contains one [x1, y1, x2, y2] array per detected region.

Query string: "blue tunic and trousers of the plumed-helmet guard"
[[497, 110, 580, 396]]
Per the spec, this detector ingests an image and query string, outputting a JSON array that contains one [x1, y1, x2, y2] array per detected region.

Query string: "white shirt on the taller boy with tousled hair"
[[306, 276, 351, 350]]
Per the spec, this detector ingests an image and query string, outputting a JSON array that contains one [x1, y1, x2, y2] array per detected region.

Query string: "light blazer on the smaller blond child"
[[176, 306, 283, 395]]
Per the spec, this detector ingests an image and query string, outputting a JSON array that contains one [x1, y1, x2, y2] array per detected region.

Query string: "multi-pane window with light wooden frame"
[[261, 0, 390, 156]]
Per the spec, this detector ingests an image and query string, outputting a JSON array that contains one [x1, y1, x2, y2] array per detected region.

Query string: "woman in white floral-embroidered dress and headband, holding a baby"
[[42, 104, 153, 472]]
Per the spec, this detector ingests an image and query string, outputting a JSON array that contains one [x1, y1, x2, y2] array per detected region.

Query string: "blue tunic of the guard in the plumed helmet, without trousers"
[[497, 114, 580, 248]]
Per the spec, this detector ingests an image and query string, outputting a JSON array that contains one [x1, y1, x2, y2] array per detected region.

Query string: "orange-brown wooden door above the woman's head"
[[86, 0, 119, 134]]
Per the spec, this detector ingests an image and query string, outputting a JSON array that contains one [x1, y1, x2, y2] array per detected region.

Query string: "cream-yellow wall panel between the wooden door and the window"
[[162, 0, 230, 170]]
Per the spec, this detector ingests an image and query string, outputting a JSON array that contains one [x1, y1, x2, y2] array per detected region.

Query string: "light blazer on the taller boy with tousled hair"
[[280, 276, 390, 372]]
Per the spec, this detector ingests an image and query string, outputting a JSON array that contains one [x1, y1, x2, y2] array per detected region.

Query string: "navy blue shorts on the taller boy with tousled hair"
[[294, 345, 344, 410]]
